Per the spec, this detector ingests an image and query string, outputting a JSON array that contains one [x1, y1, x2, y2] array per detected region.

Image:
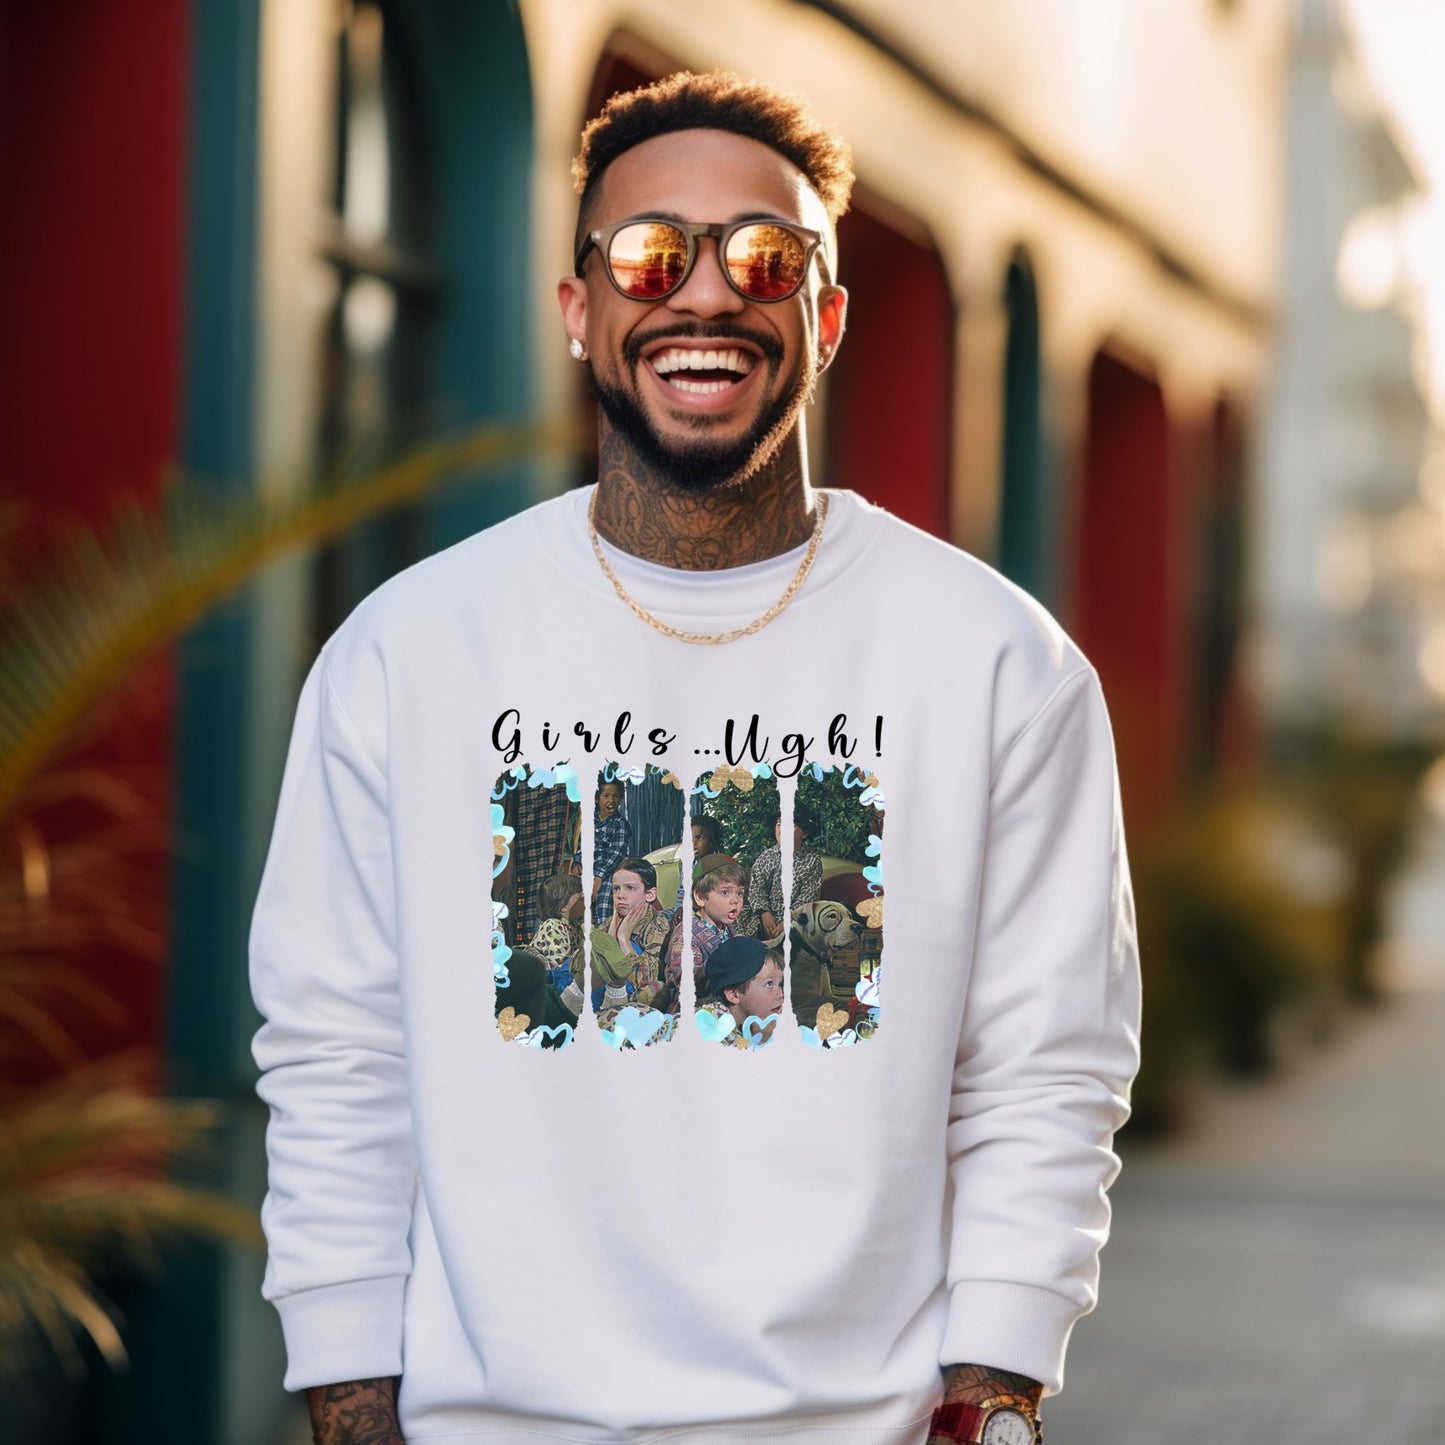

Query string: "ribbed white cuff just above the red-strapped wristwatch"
[[939, 1279, 1084, 1394]]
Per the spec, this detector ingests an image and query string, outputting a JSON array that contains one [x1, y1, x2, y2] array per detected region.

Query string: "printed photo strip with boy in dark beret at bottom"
[[684, 763, 788, 1049]]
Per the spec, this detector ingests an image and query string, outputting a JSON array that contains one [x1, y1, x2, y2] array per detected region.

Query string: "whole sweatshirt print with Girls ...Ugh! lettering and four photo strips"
[[491, 709, 884, 1052]]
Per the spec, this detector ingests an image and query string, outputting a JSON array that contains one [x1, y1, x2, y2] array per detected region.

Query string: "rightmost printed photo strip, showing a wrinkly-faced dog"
[[791, 762, 883, 1049]]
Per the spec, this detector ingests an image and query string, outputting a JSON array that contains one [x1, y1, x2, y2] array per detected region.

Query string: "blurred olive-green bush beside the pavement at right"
[[1131, 728, 1438, 1133]]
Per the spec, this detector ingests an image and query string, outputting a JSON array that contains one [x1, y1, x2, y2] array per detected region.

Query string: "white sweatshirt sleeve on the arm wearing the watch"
[[941, 666, 1139, 1394]]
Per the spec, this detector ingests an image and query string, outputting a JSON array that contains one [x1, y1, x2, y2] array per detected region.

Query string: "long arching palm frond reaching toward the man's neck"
[[0, 422, 572, 816]]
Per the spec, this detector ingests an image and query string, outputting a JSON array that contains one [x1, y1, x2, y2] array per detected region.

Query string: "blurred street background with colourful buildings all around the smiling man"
[[0, 0, 1445, 1445]]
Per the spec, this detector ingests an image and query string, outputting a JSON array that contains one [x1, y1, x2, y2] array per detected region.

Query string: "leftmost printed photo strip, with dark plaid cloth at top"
[[491, 763, 585, 1049]]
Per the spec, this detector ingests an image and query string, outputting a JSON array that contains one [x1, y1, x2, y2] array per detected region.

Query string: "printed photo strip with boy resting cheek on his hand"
[[590, 763, 683, 1049]]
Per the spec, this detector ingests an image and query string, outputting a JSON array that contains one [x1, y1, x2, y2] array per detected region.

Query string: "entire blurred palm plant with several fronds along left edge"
[[0, 423, 572, 1370]]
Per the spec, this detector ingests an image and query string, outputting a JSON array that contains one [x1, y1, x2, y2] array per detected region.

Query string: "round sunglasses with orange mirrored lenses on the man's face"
[[577, 215, 822, 303]]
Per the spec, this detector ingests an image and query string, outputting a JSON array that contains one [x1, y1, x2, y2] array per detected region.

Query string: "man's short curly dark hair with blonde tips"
[[572, 71, 853, 237]]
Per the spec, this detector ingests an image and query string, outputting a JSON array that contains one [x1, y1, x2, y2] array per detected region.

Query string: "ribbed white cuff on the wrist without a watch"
[[272, 1274, 406, 1390]]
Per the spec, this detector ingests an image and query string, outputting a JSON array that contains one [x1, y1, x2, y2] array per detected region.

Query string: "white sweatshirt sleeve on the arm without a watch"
[[251, 655, 415, 1390]]
